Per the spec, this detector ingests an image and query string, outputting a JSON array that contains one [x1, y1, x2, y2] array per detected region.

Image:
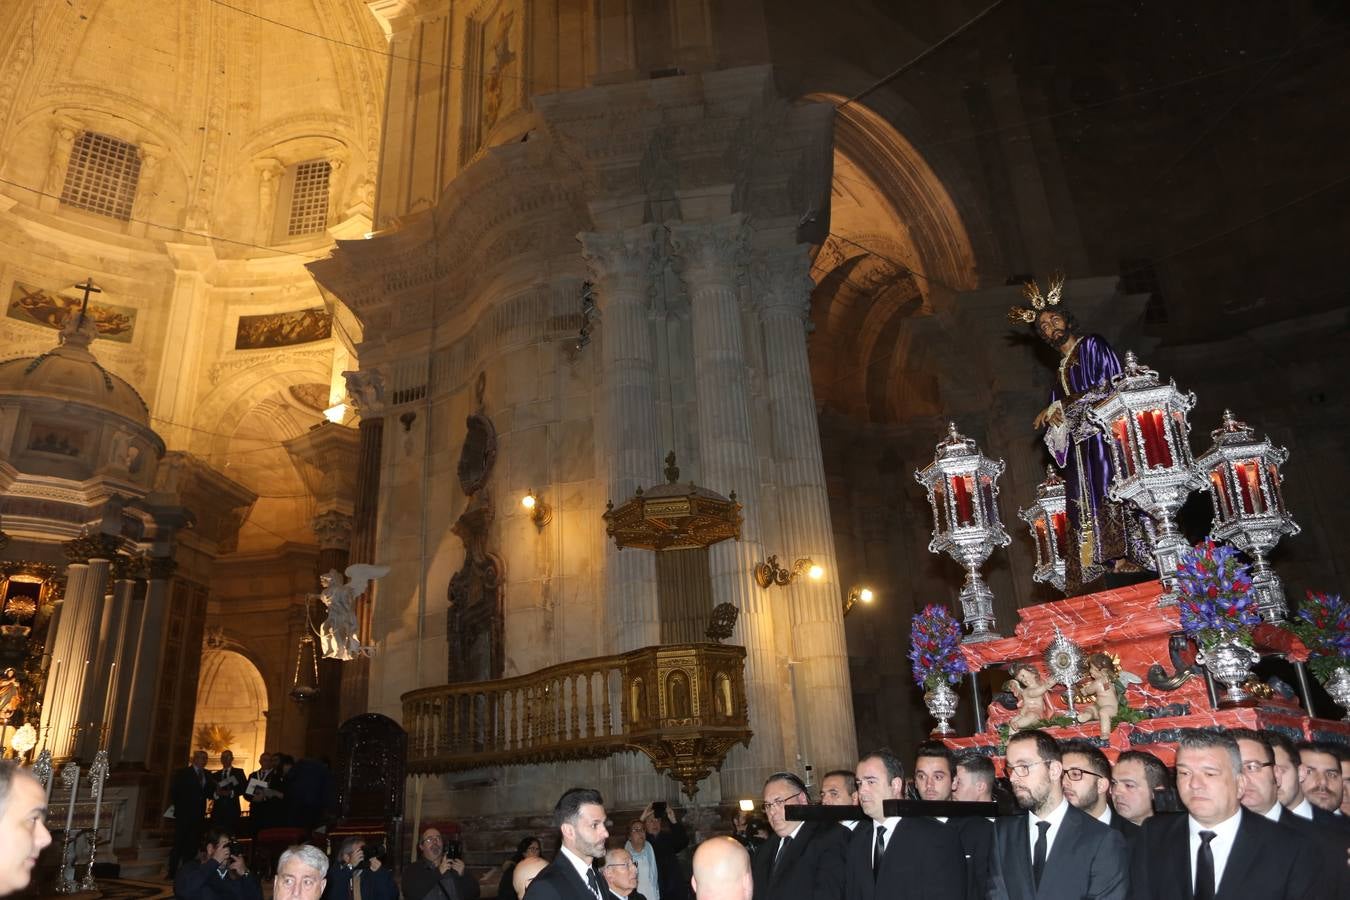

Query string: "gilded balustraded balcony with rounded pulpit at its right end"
[[402, 644, 751, 796]]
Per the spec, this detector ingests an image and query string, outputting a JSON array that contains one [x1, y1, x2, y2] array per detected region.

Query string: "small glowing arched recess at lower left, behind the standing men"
[[192, 646, 269, 772]]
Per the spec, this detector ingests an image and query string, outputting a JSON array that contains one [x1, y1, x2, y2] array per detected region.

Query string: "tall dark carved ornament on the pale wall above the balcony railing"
[[446, 375, 506, 683]]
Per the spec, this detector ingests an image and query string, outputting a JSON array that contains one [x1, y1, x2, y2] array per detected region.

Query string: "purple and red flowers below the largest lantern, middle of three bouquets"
[[1176, 540, 1261, 649]]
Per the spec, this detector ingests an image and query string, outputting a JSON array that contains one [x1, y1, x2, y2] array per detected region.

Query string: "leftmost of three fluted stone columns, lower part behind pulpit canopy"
[[579, 224, 663, 653]]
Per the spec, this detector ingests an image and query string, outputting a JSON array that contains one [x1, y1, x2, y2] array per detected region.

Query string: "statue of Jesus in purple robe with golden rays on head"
[[1008, 274, 1152, 596]]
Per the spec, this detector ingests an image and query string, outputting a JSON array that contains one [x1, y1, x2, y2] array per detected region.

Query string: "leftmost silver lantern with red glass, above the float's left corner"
[[914, 422, 1013, 644]]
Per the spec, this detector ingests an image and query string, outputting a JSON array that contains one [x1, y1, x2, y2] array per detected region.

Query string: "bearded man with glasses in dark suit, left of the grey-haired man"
[[988, 730, 1130, 900]]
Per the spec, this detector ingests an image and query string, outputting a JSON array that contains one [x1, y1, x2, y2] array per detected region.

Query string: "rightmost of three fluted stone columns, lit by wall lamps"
[[753, 247, 857, 772]]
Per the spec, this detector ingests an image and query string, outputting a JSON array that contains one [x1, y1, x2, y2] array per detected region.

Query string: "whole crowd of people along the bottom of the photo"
[[0, 729, 1350, 900]]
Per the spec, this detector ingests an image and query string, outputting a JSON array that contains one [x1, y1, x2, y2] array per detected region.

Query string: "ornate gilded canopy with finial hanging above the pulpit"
[[605, 451, 741, 551]]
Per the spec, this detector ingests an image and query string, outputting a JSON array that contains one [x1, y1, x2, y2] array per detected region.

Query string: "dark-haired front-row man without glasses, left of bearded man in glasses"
[[845, 749, 965, 900]]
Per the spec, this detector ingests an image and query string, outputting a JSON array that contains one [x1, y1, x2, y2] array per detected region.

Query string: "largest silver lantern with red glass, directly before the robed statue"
[[1088, 352, 1204, 603]]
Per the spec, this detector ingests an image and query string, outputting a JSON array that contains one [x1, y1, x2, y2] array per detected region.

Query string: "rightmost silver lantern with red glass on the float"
[[1196, 410, 1299, 622]]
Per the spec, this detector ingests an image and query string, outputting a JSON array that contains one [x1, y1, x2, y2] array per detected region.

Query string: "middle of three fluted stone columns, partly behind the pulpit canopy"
[[671, 213, 794, 796]]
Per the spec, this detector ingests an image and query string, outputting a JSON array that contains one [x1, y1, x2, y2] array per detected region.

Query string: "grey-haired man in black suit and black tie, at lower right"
[[1130, 731, 1317, 900]]
